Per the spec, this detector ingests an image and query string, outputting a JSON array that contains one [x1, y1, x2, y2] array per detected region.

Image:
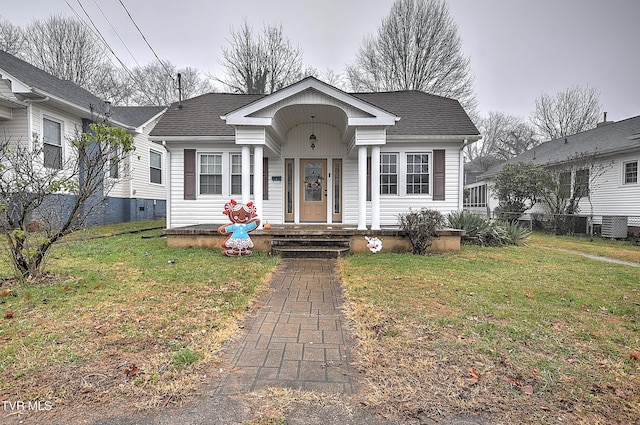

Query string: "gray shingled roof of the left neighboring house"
[[0, 50, 164, 127]]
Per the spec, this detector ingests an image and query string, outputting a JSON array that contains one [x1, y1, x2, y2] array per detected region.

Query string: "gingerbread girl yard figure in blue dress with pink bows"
[[218, 199, 260, 257]]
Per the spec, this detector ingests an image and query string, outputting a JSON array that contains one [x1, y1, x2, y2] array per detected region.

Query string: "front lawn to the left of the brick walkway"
[[0, 223, 278, 411]]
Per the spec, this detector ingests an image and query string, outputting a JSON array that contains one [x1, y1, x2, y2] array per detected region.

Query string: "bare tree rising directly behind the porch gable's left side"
[[212, 20, 302, 94]]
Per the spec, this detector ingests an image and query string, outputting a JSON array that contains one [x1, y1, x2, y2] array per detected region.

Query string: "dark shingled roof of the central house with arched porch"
[[151, 86, 480, 137]]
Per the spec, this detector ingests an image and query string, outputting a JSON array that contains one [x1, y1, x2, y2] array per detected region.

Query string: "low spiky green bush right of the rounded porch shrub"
[[447, 211, 531, 246]]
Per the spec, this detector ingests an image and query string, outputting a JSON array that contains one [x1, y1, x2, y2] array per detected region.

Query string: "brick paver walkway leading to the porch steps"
[[215, 258, 356, 394]]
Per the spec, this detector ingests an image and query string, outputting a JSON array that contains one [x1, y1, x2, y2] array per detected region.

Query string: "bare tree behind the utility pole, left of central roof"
[[125, 61, 213, 105]]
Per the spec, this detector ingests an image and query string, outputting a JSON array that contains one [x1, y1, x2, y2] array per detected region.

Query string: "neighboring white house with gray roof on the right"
[[465, 116, 640, 235]]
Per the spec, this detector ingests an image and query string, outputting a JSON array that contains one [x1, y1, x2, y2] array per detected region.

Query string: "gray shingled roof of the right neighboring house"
[[480, 116, 640, 178]]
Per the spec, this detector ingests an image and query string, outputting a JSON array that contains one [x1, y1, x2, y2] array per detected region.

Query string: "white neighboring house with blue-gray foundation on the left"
[[0, 50, 166, 223]]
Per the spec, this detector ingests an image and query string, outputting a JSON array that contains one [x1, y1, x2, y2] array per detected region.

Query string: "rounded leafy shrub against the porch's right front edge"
[[398, 208, 445, 255]]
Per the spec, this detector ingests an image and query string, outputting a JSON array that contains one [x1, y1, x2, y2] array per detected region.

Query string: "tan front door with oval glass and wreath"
[[300, 159, 327, 223]]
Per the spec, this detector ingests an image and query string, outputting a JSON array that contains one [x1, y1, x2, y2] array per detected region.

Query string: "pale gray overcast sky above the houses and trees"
[[0, 0, 640, 120]]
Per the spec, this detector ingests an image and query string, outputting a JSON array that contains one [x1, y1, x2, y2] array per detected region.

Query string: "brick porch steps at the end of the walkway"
[[271, 234, 351, 258]]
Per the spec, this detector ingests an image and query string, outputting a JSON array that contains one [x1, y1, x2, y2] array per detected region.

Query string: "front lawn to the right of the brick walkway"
[[340, 235, 640, 424]]
